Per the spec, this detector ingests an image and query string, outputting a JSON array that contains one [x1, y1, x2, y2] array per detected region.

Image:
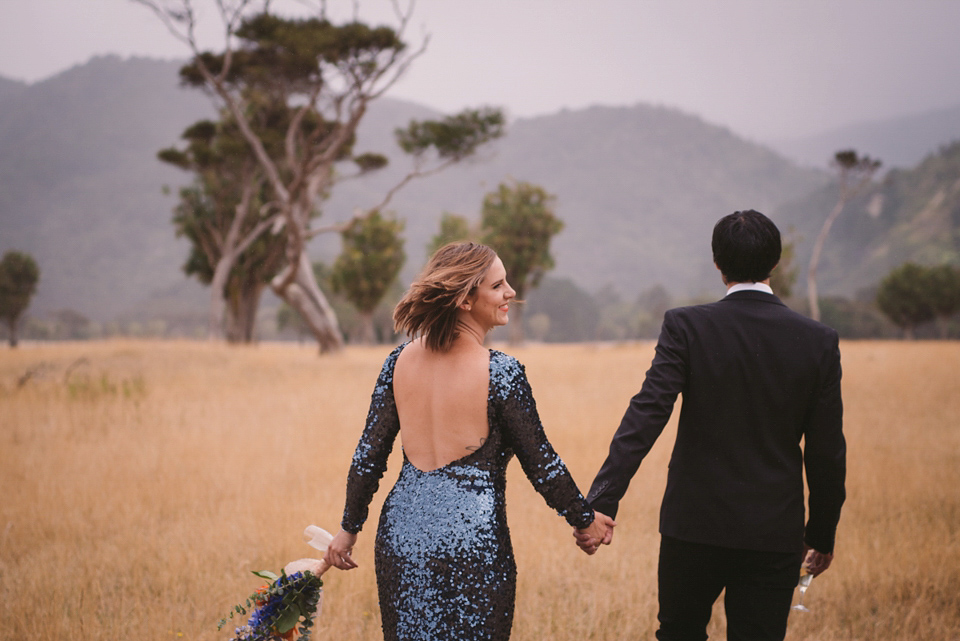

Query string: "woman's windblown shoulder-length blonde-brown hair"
[[393, 242, 497, 352]]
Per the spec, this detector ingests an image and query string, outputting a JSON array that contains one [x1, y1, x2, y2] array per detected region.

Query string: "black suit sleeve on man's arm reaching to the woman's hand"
[[587, 310, 688, 517]]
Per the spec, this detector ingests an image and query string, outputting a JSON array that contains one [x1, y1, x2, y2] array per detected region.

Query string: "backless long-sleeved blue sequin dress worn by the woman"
[[341, 345, 593, 641]]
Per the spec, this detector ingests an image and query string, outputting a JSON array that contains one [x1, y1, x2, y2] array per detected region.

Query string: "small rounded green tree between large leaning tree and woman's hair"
[[331, 210, 407, 345]]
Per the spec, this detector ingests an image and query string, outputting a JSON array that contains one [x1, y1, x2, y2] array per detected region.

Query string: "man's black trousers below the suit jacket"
[[657, 536, 803, 641]]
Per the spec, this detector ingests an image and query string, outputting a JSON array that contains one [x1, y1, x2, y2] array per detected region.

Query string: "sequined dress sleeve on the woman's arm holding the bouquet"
[[340, 346, 403, 533]]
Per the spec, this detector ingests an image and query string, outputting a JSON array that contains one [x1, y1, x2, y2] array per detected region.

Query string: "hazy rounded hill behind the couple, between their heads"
[[318, 100, 825, 296]]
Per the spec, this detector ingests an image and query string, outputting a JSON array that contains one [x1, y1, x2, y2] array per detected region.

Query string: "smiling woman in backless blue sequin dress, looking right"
[[326, 243, 610, 641]]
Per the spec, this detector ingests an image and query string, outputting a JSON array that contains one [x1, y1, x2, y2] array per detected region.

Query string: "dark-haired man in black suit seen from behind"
[[577, 210, 846, 641]]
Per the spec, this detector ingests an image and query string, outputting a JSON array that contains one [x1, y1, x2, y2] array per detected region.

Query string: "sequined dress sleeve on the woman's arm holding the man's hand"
[[490, 352, 593, 528]]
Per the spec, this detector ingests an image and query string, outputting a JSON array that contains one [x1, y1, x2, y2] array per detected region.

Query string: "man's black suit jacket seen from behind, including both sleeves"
[[587, 291, 846, 553]]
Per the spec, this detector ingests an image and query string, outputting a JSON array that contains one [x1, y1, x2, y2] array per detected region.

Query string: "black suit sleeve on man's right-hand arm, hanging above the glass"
[[803, 332, 847, 554]]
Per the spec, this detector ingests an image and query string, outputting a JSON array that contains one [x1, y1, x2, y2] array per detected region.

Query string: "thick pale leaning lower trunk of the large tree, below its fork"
[[270, 252, 343, 353]]
